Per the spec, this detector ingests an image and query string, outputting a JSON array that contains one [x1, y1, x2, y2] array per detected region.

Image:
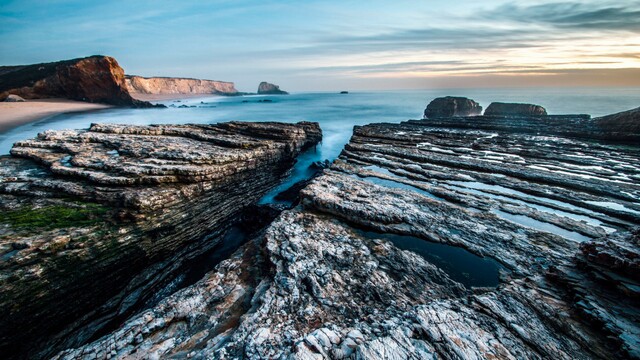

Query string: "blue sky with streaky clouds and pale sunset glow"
[[0, 0, 640, 91]]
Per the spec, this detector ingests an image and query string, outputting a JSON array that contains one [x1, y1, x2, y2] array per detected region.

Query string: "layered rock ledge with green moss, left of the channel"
[[0, 122, 322, 358]]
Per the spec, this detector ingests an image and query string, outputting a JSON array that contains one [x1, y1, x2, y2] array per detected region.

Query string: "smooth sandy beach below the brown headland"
[[0, 99, 112, 133]]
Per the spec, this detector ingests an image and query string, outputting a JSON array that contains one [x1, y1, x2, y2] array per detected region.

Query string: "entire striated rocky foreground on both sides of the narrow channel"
[[0, 98, 640, 359]]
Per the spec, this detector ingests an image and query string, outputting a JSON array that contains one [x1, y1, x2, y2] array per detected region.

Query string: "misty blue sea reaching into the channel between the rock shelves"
[[0, 88, 640, 202]]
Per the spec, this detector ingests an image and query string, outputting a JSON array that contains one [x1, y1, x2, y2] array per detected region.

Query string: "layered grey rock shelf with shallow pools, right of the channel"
[[56, 111, 640, 359]]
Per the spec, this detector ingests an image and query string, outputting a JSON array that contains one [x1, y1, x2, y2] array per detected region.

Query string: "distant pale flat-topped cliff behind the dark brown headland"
[[125, 75, 238, 97]]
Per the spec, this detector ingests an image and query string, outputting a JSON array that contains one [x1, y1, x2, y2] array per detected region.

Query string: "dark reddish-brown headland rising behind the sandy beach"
[[0, 56, 152, 107]]
